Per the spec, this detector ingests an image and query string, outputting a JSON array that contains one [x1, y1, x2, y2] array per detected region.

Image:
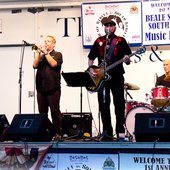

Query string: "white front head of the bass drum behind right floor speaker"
[[125, 106, 154, 140]]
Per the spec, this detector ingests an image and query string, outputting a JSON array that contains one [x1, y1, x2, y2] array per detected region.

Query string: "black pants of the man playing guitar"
[[98, 75, 125, 136]]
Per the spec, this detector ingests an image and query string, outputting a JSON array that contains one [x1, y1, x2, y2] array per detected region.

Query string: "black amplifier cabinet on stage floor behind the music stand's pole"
[[62, 113, 92, 138]]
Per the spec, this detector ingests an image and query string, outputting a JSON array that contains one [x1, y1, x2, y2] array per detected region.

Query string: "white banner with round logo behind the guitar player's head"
[[82, 2, 142, 47]]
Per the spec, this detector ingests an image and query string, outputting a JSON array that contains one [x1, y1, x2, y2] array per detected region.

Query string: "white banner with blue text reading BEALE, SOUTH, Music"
[[142, 0, 170, 45]]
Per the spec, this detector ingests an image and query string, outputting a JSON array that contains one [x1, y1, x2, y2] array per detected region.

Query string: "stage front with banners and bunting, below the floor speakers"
[[0, 139, 170, 170]]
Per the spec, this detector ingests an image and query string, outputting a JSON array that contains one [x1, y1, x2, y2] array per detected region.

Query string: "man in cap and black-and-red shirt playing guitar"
[[88, 16, 132, 141]]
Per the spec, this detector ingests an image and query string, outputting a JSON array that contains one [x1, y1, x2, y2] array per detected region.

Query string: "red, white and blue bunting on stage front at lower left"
[[0, 144, 51, 170]]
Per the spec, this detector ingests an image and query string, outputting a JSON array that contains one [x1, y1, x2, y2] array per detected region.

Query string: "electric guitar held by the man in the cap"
[[86, 47, 146, 92]]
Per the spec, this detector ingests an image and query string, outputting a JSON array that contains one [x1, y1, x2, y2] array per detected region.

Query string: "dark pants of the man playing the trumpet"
[[37, 90, 62, 134]]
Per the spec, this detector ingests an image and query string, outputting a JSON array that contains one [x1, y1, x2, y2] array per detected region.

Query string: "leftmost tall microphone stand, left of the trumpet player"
[[18, 40, 27, 114]]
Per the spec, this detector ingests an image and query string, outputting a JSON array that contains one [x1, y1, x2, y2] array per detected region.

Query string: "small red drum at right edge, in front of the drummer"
[[151, 86, 169, 107]]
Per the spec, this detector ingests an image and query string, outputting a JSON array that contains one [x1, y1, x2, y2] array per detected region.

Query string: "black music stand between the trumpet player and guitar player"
[[61, 72, 96, 139]]
